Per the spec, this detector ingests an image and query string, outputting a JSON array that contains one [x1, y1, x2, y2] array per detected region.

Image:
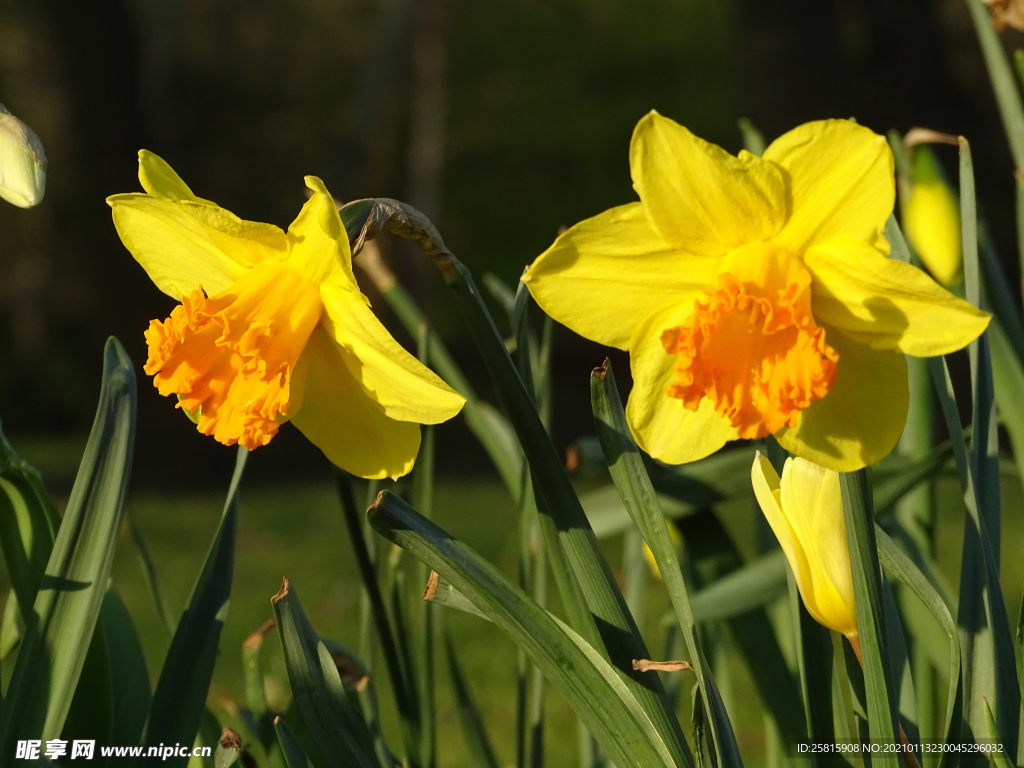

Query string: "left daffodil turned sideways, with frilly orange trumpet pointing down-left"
[[108, 150, 465, 478]]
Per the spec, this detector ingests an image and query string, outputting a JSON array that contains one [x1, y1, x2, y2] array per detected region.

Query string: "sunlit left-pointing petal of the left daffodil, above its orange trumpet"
[[106, 195, 250, 300]]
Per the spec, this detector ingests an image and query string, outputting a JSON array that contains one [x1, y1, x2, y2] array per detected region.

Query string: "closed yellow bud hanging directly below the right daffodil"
[[751, 453, 858, 648]]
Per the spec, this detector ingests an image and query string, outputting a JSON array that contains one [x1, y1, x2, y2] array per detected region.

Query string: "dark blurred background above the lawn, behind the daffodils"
[[0, 0, 1020, 487]]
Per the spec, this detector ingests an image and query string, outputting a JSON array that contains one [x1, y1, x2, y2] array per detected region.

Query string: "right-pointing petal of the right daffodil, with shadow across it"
[[804, 240, 989, 365]]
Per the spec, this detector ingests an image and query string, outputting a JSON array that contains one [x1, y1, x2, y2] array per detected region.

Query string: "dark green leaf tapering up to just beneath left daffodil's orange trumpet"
[[144, 446, 249, 766]]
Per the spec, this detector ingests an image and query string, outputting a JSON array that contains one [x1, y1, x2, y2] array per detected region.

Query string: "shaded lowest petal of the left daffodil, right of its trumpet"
[[290, 328, 420, 479]]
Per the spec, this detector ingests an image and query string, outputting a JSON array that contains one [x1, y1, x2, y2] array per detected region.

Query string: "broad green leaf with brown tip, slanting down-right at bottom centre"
[[369, 492, 680, 768]]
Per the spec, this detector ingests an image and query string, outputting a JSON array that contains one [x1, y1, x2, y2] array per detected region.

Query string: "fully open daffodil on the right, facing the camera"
[[523, 112, 988, 471]]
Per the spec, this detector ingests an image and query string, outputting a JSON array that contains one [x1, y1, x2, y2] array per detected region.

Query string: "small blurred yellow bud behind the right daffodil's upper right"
[[903, 144, 964, 286]]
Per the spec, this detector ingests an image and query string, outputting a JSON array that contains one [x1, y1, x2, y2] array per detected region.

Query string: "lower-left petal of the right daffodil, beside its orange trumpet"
[[626, 302, 736, 464]]
